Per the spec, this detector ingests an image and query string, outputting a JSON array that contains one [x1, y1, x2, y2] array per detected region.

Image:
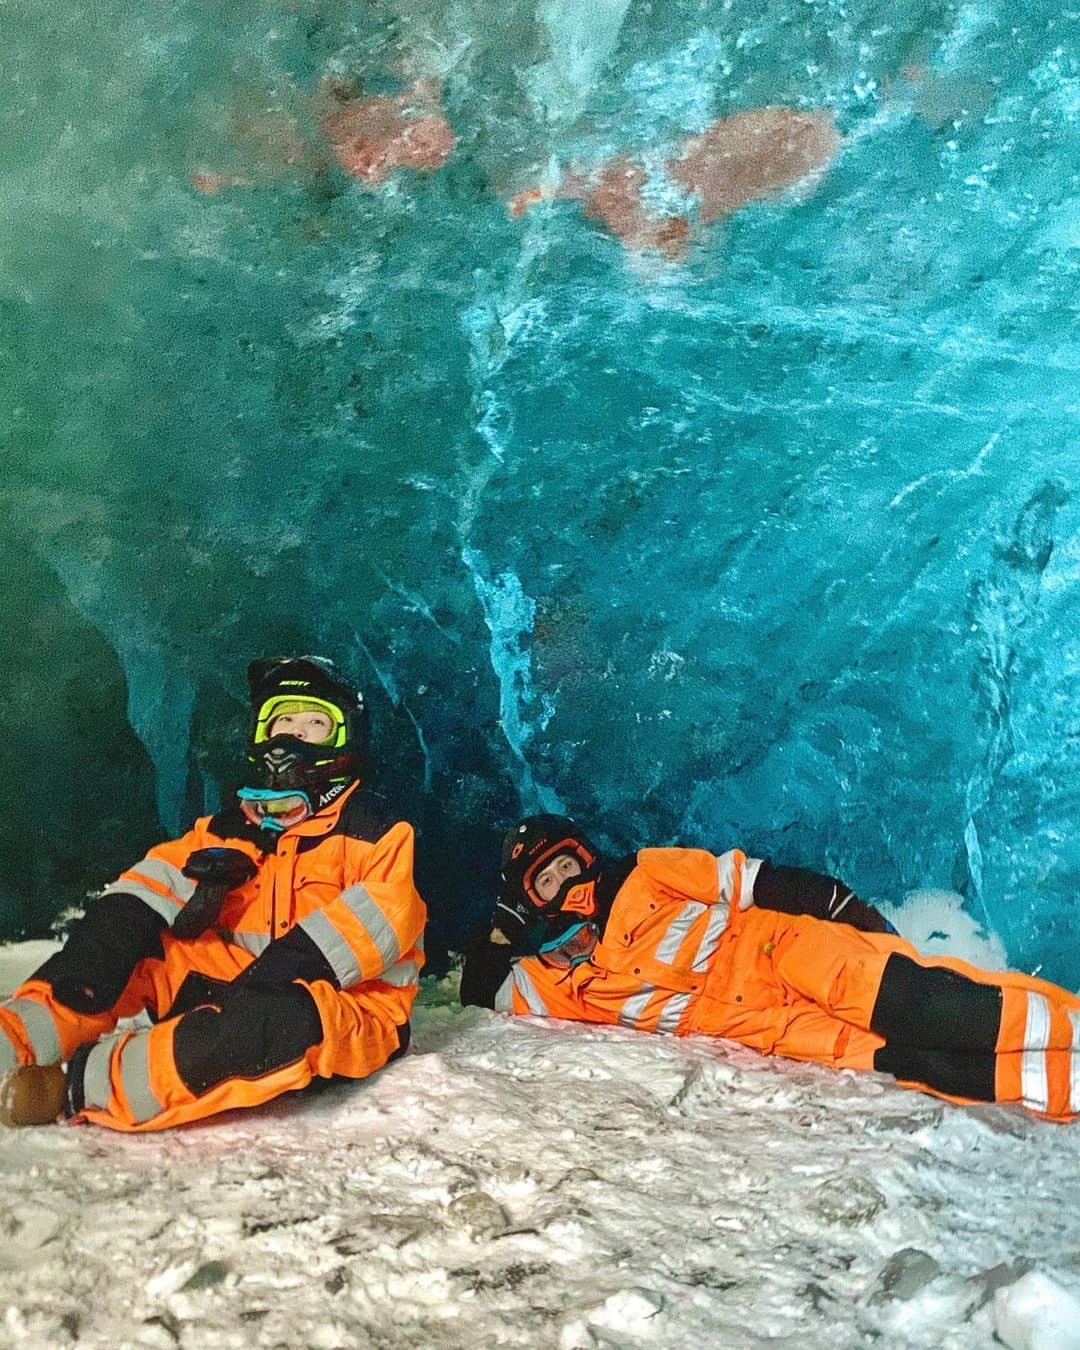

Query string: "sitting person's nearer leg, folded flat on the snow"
[[70, 981, 406, 1131]]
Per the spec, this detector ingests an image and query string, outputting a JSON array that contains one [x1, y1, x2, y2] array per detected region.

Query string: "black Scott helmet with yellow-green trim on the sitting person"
[[247, 656, 367, 810]]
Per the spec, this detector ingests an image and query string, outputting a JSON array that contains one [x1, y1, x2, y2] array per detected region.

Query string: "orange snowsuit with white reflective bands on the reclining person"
[[494, 848, 1080, 1121]]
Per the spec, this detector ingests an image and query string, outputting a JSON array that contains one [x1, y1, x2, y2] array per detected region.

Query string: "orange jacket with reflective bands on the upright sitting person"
[[105, 784, 427, 1023]]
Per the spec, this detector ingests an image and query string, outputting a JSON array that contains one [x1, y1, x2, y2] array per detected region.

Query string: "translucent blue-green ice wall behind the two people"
[[0, 0, 1080, 986]]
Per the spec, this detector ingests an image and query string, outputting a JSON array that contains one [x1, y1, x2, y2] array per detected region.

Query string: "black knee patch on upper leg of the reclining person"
[[869, 956, 1002, 1053]]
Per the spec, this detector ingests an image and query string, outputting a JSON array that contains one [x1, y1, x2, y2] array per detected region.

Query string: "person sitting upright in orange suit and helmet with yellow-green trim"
[[0, 656, 425, 1130]]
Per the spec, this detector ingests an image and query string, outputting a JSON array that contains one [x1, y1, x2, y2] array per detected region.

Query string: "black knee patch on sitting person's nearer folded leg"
[[173, 984, 323, 1096]]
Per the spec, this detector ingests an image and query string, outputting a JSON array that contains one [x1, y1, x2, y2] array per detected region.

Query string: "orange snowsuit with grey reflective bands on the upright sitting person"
[[0, 784, 427, 1130]]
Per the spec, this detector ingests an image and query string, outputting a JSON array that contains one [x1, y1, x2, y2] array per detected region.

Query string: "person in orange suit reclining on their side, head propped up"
[[460, 815, 1080, 1121]]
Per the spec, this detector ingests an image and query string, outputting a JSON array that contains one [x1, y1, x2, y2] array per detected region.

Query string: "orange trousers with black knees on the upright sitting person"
[[0, 932, 402, 1131]]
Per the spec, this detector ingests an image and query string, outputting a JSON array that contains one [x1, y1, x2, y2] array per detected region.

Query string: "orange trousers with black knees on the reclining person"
[[687, 910, 1080, 1121]]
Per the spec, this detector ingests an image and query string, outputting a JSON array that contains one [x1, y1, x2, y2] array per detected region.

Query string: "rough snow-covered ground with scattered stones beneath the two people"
[[0, 944, 1080, 1350]]
